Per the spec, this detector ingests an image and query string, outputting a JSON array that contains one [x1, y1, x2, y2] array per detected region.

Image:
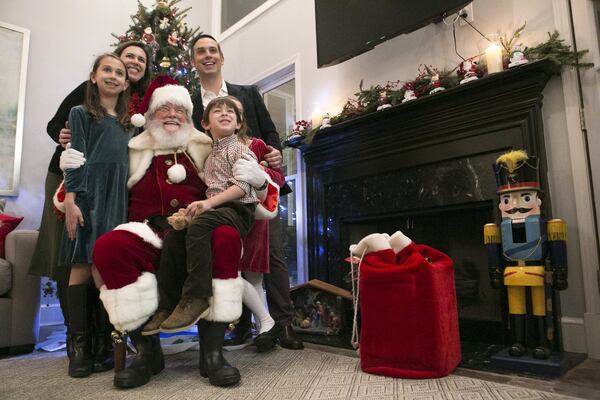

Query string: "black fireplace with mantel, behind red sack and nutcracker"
[[297, 61, 557, 343]]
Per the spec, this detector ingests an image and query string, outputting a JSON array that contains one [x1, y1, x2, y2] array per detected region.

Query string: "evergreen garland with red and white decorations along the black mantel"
[[291, 24, 594, 144]]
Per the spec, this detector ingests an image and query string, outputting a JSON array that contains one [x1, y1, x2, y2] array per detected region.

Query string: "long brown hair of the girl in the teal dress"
[[83, 53, 131, 129]]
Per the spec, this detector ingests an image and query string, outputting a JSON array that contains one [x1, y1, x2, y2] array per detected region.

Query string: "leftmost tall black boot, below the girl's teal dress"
[[68, 284, 93, 378]]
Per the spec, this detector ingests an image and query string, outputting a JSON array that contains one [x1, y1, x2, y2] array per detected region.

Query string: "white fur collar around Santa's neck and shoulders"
[[127, 129, 212, 189]]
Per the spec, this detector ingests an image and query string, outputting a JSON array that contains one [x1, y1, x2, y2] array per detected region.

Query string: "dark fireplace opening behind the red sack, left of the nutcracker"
[[342, 201, 508, 344]]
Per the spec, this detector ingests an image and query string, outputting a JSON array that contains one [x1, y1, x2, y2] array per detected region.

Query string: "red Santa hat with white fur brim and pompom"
[[131, 75, 194, 127]]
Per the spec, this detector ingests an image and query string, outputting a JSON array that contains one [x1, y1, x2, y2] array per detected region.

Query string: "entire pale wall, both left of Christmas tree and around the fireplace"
[[0, 0, 600, 358]]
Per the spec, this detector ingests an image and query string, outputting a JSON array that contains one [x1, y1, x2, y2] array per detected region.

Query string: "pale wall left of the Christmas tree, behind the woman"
[[0, 0, 210, 229]]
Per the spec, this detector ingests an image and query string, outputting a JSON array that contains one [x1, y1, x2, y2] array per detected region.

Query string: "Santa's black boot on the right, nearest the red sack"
[[198, 320, 241, 386]]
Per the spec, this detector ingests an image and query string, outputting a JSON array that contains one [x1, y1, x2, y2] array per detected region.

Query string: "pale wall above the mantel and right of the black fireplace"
[[221, 0, 600, 358]]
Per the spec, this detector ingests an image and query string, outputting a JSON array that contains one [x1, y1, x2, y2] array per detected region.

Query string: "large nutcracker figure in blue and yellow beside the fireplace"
[[484, 150, 567, 359]]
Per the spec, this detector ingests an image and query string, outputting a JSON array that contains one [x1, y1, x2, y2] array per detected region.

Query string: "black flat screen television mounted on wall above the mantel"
[[315, 0, 472, 68]]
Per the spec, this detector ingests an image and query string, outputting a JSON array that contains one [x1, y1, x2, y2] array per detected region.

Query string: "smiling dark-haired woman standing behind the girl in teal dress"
[[29, 41, 152, 372]]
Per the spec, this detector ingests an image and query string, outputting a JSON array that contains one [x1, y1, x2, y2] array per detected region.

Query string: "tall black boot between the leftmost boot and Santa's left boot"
[[92, 288, 115, 372]]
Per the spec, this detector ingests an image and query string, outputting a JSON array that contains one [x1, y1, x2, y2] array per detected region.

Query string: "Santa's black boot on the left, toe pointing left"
[[114, 328, 165, 389]]
